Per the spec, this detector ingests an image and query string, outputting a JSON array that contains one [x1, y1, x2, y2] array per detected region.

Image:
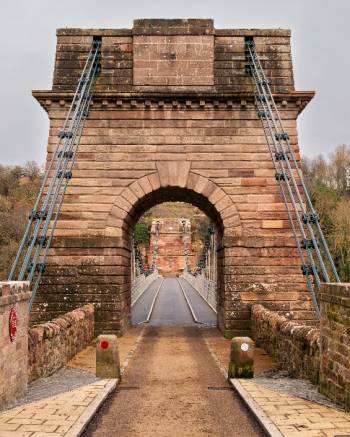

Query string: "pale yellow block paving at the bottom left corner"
[[0, 379, 114, 437]]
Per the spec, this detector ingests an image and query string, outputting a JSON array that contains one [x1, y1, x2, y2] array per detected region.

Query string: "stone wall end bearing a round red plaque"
[[0, 281, 31, 408]]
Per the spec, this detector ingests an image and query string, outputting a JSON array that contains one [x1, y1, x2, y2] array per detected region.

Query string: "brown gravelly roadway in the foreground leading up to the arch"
[[83, 326, 265, 437]]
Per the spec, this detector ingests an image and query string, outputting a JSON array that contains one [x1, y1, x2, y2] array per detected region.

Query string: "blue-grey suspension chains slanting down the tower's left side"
[[8, 39, 101, 309]]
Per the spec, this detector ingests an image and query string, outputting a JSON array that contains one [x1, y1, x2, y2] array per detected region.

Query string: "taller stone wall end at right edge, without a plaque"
[[319, 284, 350, 411]]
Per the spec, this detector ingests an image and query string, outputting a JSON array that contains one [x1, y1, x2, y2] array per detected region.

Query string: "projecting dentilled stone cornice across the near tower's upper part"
[[32, 90, 315, 113]]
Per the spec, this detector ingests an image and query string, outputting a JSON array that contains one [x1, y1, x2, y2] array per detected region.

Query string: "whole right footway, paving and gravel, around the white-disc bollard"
[[202, 329, 350, 437]]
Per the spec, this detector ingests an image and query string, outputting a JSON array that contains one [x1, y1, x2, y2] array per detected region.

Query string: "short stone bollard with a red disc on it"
[[96, 335, 121, 379]]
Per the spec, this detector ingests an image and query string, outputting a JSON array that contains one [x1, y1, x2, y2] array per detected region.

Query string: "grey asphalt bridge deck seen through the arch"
[[132, 278, 216, 326]]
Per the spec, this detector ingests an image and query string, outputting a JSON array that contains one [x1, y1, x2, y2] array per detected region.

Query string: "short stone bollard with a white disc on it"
[[228, 337, 254, 378]]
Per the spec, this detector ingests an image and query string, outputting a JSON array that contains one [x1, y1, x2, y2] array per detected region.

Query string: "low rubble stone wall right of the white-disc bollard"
[[252, 305, 320, 384]]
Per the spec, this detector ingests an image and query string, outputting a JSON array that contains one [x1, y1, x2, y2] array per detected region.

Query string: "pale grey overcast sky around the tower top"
[[0, 0, 350, 164]]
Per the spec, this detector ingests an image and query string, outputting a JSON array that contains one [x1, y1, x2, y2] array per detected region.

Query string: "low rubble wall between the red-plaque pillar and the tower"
[[28, 305, 94, 382]]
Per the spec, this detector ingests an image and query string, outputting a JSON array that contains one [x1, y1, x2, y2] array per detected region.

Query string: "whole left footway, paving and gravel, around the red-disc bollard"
[[0, 328, 143, 437]]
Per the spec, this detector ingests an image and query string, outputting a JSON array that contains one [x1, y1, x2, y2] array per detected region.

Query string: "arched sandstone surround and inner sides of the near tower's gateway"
[[105, 161, 241, 330]]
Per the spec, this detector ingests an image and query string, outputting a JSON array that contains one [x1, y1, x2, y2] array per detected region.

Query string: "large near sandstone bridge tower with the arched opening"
[[32, 20, 314, 335]]
